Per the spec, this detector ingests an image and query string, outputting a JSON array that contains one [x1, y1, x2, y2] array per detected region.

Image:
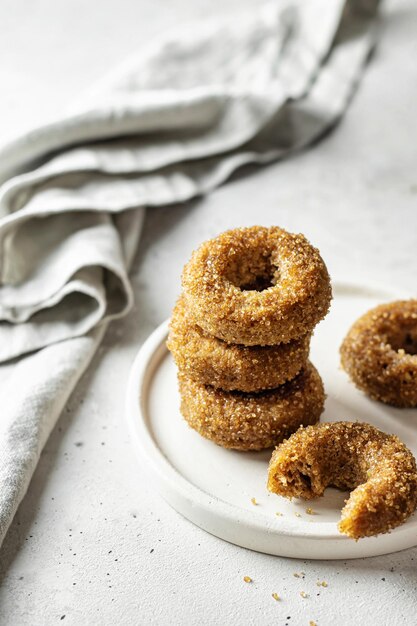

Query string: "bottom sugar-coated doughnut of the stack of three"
[[178, 362, 325, 450]]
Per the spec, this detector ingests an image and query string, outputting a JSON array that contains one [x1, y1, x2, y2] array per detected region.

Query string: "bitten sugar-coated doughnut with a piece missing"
[[268, 422, 417, 539]]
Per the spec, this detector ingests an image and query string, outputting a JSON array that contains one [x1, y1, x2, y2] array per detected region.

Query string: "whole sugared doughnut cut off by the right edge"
[[340, 300, 417, 407]]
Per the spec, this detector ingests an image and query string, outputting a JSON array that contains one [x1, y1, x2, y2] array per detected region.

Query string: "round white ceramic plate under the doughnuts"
[[127, 283, 417, 559]]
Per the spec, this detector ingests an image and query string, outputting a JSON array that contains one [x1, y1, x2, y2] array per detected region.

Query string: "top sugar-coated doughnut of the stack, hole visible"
[[182, 226, 331, 345]]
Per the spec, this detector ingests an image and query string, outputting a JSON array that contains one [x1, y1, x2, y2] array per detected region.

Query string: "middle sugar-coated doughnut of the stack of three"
[[167, 296, 310, 391]]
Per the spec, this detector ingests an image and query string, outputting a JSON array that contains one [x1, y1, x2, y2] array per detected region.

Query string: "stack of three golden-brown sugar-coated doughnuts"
[[167, 226, 331, 450]]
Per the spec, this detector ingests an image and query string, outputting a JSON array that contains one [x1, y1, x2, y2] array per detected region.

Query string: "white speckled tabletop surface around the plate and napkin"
[[0, 0, 417, 626]]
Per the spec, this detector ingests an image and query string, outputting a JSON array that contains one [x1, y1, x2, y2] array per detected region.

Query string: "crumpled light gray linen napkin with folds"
[[0, 0, 377, 541]]
